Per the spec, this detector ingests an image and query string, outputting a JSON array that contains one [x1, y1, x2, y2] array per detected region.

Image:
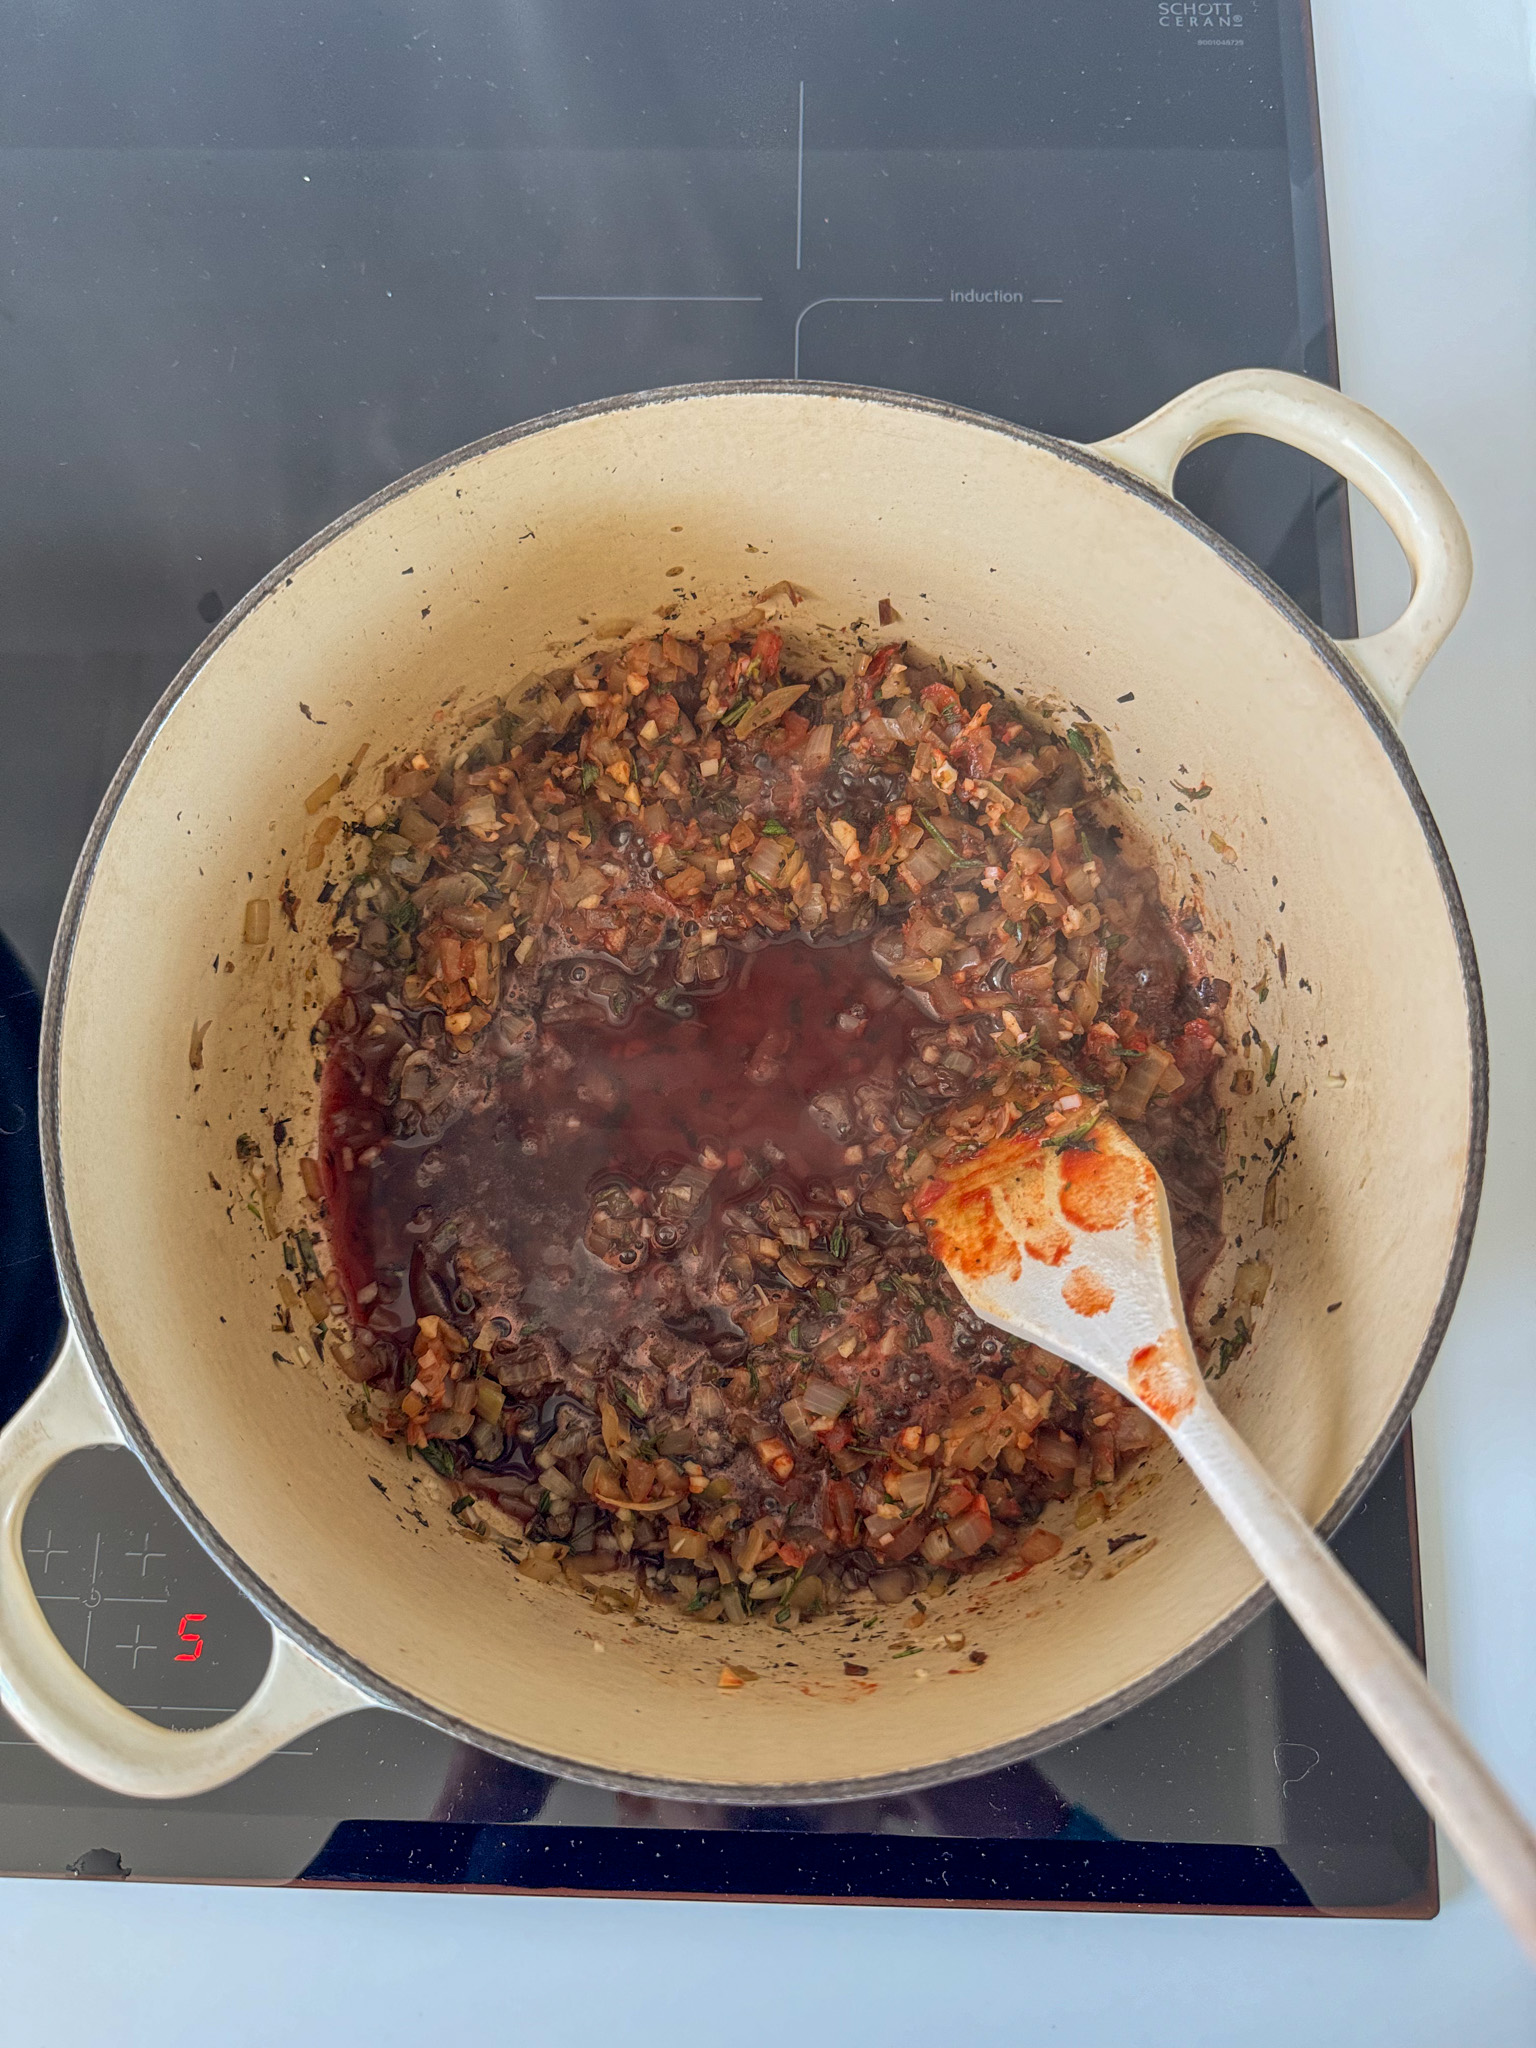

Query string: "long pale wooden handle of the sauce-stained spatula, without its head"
[[1176, 1391, 1536, 1962]]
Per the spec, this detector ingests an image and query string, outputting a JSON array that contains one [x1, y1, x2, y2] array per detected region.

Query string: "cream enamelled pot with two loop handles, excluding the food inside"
[[0, 371, 1485, 1800]]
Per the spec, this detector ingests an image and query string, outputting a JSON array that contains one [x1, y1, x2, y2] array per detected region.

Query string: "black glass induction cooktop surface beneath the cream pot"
[[0, 0, 1436, 1915]]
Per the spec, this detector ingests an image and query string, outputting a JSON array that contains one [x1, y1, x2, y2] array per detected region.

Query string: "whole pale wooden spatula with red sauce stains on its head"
[[913, 1092, 1536, 1962]]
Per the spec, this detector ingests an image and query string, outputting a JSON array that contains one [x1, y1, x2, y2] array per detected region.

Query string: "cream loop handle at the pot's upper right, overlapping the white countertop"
[[1092, 371, 1473, 723]]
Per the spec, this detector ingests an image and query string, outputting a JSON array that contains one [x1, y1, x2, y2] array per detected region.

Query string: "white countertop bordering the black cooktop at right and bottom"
[[0, 0, 1536, 2048]]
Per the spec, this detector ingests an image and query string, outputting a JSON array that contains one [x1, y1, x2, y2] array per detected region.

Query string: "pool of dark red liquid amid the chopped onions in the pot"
[[322, 940, 932, 1358]]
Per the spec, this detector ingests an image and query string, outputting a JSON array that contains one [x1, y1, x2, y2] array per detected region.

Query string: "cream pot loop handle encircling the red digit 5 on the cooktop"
[[0, 1331, 377, 1798]]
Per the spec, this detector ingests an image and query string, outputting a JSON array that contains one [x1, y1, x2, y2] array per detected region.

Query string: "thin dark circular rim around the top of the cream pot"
[[39, 379, 1489, 1806]]
